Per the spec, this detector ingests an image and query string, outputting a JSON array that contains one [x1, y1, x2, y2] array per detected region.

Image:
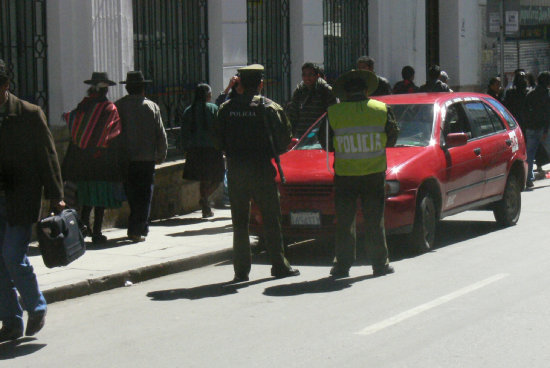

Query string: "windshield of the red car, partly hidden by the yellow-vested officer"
[[294, 104, 433, 150]]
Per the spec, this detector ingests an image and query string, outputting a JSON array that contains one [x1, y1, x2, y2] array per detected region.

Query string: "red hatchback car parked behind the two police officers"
[[250, 93, 527, 251]]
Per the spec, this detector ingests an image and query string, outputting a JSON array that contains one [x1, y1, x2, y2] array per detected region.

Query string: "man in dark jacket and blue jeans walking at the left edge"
[[0, 60, 65, 342]]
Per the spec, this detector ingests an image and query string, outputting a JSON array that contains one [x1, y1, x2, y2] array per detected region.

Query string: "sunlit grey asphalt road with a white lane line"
[[0, 181, 550, 368]]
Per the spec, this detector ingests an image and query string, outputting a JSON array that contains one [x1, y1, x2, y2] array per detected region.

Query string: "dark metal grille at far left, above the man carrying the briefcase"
[[0, 0, 48, 114]]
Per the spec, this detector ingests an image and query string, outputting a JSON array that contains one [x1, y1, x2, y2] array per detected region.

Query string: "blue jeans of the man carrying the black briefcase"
[[0, 195, 46, 326]]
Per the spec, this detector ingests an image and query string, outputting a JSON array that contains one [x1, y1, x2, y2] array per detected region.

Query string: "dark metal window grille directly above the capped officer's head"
[[247, 0, 291, 105]]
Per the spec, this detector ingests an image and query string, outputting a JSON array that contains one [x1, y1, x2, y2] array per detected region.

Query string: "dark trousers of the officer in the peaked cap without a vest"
[[227, 160, 290, 275]]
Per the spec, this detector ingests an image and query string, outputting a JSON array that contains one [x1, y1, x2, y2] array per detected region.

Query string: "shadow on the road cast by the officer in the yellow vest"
[[264, 276, 373, 296]]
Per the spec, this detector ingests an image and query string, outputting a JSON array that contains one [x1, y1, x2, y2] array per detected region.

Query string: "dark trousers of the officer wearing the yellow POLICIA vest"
[[334, 172, 389, 268]]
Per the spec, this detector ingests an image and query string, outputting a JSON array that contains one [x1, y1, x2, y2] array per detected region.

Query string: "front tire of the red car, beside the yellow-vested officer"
[[411, 193, 437, 253]]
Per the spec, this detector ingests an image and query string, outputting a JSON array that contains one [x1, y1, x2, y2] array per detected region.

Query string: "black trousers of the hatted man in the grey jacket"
[[124, 161, 155, 236]]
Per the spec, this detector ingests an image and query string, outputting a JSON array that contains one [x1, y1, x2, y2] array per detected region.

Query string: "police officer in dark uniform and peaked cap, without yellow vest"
[[217, 64, 300, 282]]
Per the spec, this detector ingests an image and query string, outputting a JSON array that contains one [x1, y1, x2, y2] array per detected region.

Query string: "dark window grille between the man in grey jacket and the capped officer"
[[133, 0, 209, 156]]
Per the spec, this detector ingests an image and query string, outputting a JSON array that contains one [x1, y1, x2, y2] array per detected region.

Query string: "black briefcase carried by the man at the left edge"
[[36, 209, 86, 268]]
